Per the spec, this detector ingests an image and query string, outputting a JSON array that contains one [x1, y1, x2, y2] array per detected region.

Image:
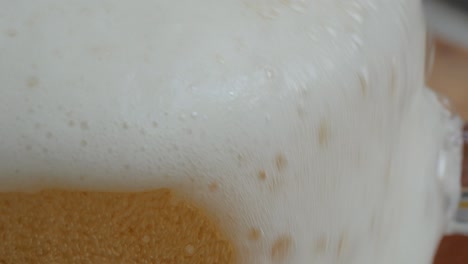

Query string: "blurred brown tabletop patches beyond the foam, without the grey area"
[[428, 41, 468, 264]]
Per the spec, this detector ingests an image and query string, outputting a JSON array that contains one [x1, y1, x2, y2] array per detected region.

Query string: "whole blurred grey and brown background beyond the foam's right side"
[[424, 0, 468, 264]]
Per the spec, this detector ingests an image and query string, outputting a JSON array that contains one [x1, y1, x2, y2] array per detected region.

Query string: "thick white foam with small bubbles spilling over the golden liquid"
[[0, 0, 454, 264]]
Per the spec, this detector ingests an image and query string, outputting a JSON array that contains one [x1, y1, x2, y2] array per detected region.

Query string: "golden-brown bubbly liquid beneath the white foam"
[[0, 189, 235, 264]]
